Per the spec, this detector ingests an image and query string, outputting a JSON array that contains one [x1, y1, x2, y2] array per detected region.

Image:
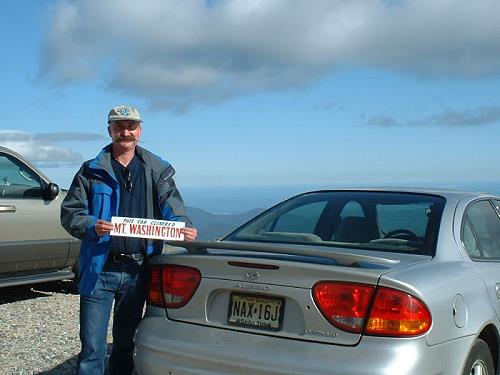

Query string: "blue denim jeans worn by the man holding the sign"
[[77, 260, 146, 375]]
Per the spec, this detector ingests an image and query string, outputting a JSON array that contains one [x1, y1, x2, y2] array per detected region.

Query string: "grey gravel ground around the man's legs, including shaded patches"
[[0, 281, 112, 375]]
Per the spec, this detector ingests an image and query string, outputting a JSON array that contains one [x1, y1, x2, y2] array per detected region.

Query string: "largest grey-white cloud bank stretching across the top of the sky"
[[40, 0, 500, 110]]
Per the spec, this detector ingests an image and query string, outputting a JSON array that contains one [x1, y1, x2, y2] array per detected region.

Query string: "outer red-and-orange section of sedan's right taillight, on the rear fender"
[[365, 287, 432, 336]]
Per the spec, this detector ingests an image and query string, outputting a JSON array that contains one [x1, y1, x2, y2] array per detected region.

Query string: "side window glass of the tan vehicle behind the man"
[[0, 154, 42, 199]]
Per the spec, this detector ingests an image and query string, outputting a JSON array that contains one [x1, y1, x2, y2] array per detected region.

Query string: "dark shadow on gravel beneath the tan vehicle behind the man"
[[0, 280, 78, 305]]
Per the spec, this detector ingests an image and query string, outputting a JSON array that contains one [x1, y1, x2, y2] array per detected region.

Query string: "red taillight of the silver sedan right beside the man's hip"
[[147, 265, 201, 309]]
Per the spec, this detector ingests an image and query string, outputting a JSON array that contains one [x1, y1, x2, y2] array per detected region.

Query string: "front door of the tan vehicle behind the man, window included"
[[0, 151, 69, 276]]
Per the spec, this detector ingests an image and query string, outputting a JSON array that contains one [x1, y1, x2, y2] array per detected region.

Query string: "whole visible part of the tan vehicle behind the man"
[[0, 146, 79, 287]]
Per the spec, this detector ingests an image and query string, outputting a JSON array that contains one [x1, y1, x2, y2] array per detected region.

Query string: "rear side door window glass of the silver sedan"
[[466, 200, 500, 259]]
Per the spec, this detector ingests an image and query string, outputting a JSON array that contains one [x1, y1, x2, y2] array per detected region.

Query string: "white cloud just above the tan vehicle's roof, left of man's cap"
[[0, 130, 104, 167]]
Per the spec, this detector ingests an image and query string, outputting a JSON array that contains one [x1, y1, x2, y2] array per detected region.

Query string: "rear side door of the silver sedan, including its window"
[[462, 199, 500, 318]]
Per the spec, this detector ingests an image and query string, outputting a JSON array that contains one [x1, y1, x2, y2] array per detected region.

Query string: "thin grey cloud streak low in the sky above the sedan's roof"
[[366, 105, 500, 127]]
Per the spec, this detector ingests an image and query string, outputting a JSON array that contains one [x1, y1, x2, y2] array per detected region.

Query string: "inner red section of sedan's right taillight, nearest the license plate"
[[313, 281, 374, 333]]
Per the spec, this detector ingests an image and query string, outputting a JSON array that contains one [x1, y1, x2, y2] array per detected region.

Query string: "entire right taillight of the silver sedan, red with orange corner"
[[312, 281, 432, 337]]
